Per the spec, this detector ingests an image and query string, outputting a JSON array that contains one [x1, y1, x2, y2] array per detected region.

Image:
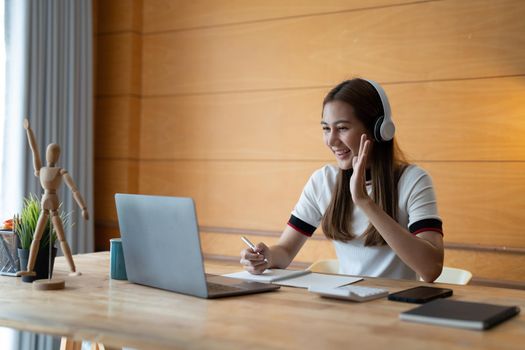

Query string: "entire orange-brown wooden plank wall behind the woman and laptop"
[[96, 0, 525, 281]]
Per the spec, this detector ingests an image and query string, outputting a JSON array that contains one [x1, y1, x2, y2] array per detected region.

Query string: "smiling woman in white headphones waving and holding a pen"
[[240, 79, 443, 282]]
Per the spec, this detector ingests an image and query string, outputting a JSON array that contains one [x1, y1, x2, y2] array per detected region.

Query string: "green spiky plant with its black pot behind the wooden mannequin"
[[14, 194, 69, 282]]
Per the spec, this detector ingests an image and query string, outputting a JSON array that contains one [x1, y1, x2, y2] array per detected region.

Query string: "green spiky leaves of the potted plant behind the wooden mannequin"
[[14, 194, 70, 249]]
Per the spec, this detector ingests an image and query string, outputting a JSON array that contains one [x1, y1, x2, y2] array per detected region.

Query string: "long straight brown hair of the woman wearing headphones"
[[322, 78, 408, 246]]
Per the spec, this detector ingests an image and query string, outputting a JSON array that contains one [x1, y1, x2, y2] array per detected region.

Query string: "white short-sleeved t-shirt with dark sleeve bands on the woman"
[[288, 165, 443, 279]]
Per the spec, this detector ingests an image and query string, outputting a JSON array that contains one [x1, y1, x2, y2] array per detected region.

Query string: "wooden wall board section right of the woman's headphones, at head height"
[[386, 76, 525, 164]]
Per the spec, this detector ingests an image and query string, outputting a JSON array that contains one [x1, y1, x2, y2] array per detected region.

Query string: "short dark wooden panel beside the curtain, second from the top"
[[96, 32, 142, 95]]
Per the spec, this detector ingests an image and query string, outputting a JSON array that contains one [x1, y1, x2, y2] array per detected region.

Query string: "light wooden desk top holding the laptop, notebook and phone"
[[0, 252, 525, 350]]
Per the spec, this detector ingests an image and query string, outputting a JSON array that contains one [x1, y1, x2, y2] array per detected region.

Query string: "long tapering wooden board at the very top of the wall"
[[143, 0, 414, 33]]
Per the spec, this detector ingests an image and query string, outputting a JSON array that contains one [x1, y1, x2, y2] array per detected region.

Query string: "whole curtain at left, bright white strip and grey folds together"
[[0, 0, 94, 349]]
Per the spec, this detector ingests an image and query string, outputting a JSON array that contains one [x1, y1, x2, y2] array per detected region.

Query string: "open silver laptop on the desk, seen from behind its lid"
[[115, 193, 279, 298]]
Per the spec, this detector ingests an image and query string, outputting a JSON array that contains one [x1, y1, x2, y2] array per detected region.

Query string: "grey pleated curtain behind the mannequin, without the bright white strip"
[[12, 0, 94, 254]]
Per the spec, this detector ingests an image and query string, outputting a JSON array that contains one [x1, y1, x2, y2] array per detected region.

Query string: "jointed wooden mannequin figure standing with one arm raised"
[[17, 119, 89, 289]]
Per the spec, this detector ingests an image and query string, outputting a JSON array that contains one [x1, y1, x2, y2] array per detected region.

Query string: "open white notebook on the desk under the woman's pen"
[[224, 269, 362, 288]]
